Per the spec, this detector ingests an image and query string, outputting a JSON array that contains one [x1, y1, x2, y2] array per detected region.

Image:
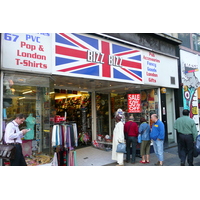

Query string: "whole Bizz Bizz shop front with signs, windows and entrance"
[[0, 33, 179, 166]]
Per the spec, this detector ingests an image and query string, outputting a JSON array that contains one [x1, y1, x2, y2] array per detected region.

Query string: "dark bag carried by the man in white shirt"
[[0, 131, 16, 160]]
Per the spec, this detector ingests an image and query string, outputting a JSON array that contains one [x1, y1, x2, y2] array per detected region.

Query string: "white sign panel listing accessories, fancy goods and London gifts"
[[143, 50, 178, 88]]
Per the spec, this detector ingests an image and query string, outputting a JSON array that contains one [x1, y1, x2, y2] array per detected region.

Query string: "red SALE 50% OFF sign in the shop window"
[[128, 94, 141, 113]]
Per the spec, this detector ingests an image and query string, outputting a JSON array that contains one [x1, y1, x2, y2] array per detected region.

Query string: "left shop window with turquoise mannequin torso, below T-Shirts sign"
[[3, 73, 51, 165]]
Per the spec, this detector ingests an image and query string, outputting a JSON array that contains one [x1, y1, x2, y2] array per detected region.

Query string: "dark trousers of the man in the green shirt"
[[179, 133, 194, 166]]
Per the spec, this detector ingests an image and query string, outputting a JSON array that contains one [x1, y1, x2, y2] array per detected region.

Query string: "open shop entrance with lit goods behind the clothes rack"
[[54, 89, 92, 146]]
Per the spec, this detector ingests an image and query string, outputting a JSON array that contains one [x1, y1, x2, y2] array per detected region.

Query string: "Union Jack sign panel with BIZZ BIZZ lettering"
[[55, 33, 143, 83]]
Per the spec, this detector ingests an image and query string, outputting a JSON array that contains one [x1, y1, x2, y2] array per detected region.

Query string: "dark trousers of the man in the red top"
[[126, 136, 137, 162]]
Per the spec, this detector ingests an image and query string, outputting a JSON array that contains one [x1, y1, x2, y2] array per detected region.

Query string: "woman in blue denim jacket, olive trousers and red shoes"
[[139, 117, 151, 164]]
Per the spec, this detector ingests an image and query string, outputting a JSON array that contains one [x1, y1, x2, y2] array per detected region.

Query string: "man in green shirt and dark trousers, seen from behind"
[[174, 109, 198, 166]]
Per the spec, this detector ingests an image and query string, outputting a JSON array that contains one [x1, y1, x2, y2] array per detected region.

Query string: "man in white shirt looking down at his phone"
[[5, 114, 28, 166]]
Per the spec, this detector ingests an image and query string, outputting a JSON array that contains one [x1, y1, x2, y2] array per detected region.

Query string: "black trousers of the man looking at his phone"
[[10, 144, 27, 166]]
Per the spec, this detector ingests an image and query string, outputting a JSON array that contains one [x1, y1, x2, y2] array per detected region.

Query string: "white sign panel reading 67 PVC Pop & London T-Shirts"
[[1, 33, 52, 74]]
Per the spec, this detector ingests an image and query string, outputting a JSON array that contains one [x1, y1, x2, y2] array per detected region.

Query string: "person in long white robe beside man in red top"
[[112, 114, 124, 166]]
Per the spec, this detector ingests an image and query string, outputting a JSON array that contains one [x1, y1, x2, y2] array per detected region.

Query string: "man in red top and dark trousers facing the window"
[[124, 116, 139, 164]]
